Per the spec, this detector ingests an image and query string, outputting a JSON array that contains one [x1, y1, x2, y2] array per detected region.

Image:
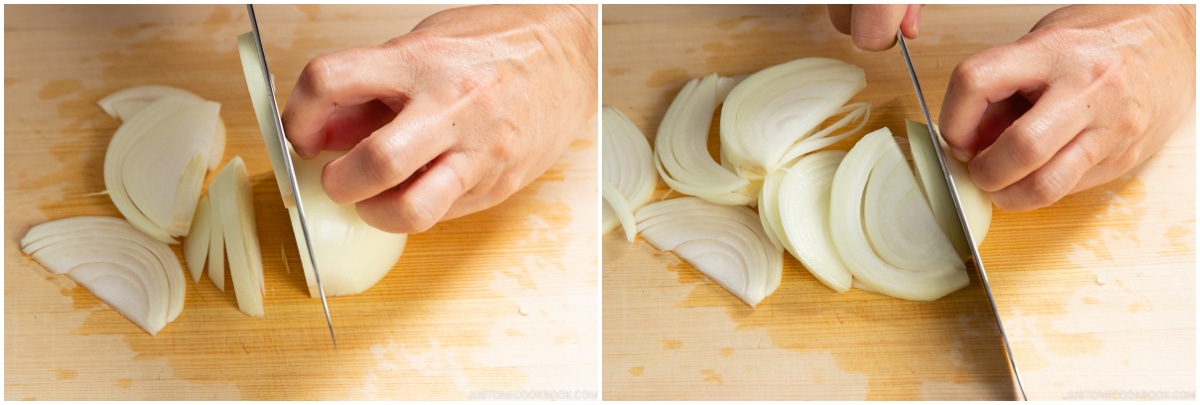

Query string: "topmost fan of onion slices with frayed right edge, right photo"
[[721, 58, 869, 182]]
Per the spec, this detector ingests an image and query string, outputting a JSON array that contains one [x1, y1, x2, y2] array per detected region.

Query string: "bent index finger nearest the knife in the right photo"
[[941, 43, 1048, 162]]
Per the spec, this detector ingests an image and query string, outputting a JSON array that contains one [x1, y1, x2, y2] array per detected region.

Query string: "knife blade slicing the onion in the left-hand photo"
[[244, 5, 337, 351]]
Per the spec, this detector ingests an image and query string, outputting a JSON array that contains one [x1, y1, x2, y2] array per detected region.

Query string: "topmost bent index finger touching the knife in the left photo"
[[282, 47, 412, 158]]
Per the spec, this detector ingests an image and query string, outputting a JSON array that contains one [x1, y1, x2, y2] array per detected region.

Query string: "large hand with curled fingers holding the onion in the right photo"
[[941, 5, 1195, 211]]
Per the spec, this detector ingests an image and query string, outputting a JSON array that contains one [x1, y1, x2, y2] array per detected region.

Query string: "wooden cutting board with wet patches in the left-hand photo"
[[4, 5, 599, 400]]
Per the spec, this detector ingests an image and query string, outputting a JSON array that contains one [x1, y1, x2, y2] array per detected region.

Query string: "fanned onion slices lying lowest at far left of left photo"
[[20, 217, 185, 336]]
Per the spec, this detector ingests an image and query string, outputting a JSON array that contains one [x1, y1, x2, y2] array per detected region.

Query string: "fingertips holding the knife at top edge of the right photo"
[[826, 5, 924, 50]]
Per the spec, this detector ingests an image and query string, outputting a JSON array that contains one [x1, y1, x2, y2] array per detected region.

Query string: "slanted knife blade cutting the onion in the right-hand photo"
[[896, 32, 1028, 400]]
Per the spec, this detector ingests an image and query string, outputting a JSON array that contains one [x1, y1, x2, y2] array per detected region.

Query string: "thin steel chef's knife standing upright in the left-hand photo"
[[238, 5, 337, 350]]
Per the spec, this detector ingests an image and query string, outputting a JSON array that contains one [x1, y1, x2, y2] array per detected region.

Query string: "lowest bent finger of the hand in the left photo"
[[356, 153, 486, 234]]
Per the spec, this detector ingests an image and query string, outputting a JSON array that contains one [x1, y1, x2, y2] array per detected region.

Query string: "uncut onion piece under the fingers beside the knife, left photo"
[[288, 151, 408, 297]]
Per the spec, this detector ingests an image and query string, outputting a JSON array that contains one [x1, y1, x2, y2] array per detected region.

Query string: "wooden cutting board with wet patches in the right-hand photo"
[[601, 5, 1196, 399]]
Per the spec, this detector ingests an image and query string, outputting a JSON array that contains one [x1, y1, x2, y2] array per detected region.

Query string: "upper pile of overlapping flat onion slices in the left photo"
[[100, 86, 224, 243]]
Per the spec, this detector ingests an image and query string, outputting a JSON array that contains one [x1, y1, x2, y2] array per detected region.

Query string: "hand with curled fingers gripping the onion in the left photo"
[[283, 6, 598, 232]]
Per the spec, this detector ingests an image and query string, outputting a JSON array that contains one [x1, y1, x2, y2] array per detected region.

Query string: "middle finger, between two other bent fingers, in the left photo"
[[320, 102, 455, 204]]
